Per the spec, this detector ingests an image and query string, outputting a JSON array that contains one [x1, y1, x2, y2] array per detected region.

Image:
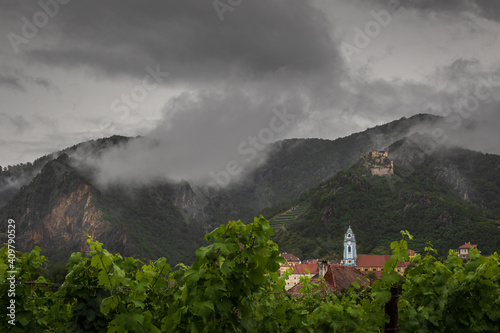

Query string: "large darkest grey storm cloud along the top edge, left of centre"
[[22, 0, 338, 81]]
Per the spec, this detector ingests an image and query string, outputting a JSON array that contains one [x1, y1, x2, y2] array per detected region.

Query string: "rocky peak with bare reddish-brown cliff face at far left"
[[0, 155, 134, 260]]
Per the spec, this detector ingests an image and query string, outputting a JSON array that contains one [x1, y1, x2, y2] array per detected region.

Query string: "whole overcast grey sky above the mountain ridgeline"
[[0, 0, 500, 177]]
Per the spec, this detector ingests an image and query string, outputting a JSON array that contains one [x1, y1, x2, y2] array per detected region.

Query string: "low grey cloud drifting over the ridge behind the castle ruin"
[[336, 58, 500, 154]]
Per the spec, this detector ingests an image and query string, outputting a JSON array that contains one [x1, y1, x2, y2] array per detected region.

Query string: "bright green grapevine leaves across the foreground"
[[0, 216, 500, 332]]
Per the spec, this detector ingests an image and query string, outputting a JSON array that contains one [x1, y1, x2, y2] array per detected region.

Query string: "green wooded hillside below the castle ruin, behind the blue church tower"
[[270, 135, 500, 259]]
